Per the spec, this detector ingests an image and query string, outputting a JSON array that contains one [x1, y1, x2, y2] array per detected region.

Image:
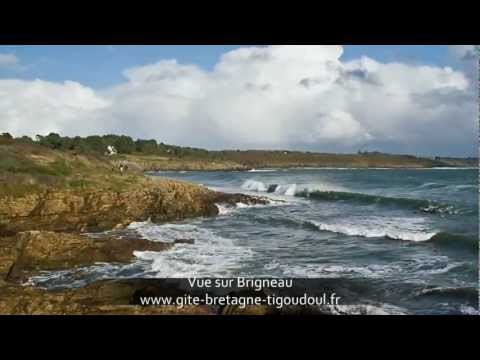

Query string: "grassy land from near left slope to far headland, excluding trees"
[[0, 139, 476, 197]]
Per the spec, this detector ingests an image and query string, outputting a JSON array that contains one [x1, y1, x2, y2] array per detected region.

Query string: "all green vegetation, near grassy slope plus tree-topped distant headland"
[[0, 133, 478, 196]]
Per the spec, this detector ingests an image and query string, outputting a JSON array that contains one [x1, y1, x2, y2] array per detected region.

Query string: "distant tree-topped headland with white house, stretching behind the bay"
[[0, 133, 478, 171]]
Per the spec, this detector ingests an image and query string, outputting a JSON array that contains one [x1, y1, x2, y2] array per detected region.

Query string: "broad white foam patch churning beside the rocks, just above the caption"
[[134, 224, 253, 278]]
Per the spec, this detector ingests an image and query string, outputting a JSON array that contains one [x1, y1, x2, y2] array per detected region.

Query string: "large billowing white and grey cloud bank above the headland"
[[0, 46, 478, 156]]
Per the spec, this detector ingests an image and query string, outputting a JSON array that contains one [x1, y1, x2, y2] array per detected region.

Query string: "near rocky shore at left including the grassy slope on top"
[[0, 148, 274, 314]]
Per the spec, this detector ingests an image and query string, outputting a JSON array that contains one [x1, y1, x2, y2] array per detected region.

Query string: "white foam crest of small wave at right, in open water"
[[310, 217, 437, 241]]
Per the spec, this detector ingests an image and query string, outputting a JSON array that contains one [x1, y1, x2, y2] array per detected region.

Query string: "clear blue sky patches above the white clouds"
[[0, 45, 459, 89]]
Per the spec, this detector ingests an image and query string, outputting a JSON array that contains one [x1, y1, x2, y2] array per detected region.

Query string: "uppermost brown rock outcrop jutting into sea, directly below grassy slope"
[[0, 180, 268, 236]]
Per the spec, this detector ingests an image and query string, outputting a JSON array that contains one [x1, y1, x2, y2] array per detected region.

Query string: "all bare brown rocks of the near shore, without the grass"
[[0, 178, 268, 314]]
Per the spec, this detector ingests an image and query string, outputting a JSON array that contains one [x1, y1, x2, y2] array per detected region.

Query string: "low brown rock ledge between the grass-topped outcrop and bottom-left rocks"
[[0, 231, 172, 281]]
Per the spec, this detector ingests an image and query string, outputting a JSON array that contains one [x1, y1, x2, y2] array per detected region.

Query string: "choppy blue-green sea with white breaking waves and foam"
[[32, 169, 479, 314]]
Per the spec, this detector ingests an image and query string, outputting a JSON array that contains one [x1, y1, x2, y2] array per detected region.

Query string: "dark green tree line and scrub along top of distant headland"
[[0, 133, 478, 167]]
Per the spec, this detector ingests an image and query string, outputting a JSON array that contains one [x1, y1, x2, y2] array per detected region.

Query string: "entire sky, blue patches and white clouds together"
[[0, 45, 478, 156]]
